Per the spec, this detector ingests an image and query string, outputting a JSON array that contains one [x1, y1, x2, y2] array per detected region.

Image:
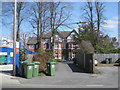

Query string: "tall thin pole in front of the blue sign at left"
[[13, 0, 17, 76]]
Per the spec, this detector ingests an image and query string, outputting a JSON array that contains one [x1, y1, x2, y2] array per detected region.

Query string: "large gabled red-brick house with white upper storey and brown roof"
[[27, 30, 78, 60]]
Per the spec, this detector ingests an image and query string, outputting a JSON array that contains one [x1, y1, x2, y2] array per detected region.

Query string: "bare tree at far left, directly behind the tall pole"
[[2, 2, 27, 41]]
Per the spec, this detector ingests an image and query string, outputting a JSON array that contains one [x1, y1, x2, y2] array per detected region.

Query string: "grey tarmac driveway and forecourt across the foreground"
[[2, 62, 118, 88]]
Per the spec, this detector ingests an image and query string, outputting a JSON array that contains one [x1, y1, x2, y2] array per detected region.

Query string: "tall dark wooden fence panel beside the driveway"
[[74, 53, 94, 73]]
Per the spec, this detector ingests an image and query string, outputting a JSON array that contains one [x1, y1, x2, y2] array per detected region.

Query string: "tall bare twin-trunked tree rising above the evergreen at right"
[[82, 0, 105, 32]]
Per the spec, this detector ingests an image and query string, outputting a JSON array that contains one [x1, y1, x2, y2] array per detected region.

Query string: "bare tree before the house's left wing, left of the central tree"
[[29, 2, 49, 48]]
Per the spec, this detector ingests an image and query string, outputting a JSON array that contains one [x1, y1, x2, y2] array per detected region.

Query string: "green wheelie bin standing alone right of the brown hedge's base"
[[46, 62, 56, 76]]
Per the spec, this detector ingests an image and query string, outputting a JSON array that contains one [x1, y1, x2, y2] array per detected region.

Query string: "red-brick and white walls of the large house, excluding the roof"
[[27, 32, 76, 60]]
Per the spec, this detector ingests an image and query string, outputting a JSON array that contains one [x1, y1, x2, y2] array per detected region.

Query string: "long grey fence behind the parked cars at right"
[[94, 54, 120, 63]]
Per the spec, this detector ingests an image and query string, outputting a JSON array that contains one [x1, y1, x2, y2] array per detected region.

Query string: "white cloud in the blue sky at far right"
[[103, 20, 118, 28]]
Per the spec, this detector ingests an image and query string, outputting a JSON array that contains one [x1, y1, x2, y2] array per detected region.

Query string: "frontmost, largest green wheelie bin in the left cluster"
[[23, 62, 34, 79]]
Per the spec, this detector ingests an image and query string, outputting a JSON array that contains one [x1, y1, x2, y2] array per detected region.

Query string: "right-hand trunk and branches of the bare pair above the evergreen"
[[95, 2, 105, 32]]
